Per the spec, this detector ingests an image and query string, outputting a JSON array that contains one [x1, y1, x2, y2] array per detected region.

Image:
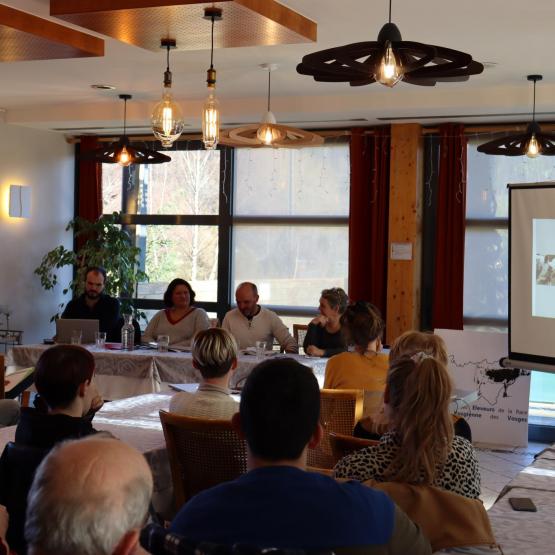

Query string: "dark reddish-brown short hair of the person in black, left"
[[35, 345, 94, 409]]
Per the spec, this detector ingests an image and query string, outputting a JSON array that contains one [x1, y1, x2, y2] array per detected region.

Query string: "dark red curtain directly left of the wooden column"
[[349, 126, 391, 319]]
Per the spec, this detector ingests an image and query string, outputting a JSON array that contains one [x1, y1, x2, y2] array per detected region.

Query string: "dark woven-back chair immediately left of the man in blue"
[[160, 410, 247, 510]]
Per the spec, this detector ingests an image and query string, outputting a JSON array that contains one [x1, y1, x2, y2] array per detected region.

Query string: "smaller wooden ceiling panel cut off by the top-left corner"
[[0, 4, 104, 62]]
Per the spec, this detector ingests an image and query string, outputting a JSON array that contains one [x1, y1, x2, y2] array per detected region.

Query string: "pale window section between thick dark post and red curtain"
[[232, 143, 350, 322]]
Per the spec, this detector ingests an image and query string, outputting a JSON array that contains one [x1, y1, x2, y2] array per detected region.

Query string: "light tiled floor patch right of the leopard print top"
[[476, 443, 547, 509]]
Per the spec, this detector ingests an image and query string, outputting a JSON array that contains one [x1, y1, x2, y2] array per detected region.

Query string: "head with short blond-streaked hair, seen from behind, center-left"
[[192, 328, 237, 379]]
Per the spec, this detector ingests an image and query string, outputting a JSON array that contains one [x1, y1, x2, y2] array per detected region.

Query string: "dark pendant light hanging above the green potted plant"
[[80, 94, 171, 167]]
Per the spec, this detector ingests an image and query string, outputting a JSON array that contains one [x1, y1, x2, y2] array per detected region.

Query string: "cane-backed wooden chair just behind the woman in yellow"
[[307, 389, 364, 468]]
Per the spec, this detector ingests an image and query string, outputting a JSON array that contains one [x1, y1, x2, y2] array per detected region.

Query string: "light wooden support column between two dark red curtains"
[[386, 123, 422, 343]]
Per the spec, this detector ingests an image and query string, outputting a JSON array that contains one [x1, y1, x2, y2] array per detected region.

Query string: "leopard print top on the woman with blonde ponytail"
[[334, 432, 480, 499]]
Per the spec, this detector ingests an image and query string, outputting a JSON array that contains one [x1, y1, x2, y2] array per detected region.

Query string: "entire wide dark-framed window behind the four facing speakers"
[[102, 136, 350, 323]]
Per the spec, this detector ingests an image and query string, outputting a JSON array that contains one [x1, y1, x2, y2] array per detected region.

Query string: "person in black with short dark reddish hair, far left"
[[15, 345, 102, 449]]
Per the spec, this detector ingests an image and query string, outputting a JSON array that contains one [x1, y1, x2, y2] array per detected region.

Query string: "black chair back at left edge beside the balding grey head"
[[0, 441, 48, 555]]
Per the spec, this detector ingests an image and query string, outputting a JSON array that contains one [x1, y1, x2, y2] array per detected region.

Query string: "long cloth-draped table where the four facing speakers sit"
[[9, 345, 327, 400]]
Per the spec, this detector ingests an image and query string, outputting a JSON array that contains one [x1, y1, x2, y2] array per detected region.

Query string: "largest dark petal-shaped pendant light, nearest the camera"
[[297, 0, 484, 87]]
